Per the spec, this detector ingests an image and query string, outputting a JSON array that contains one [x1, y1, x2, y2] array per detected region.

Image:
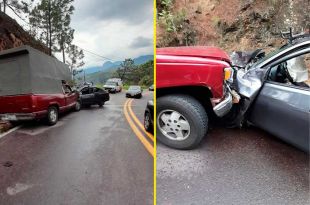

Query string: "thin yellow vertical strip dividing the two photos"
[[153, 0, 157, 205]]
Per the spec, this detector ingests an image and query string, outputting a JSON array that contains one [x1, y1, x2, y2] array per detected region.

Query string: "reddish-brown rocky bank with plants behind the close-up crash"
[[157, 0, 310, 51]]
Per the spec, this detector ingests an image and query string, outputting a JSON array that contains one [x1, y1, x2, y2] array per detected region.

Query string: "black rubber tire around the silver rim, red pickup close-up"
[[156, 94, 208, 150]]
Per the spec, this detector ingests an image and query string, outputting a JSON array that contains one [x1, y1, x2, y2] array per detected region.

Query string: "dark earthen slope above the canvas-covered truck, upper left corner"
[[0, 12, 48, 54]]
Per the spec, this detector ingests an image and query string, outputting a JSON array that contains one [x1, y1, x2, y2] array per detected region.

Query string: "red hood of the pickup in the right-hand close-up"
[[156, 46, 230, 63]]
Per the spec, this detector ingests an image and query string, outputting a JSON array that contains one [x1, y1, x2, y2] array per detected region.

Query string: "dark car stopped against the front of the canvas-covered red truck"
[[80, 86, 110, 107]]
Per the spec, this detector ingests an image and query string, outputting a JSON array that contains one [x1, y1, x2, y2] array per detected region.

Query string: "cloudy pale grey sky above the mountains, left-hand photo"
[[9, 0, 153, 67]]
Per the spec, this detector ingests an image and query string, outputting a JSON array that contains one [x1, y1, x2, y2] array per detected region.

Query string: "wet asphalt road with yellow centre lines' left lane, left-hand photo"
[[0, 92, 153, 205]]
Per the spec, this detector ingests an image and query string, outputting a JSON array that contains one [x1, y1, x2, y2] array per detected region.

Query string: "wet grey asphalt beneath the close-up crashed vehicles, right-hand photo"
[[157, 127, 310, 205]]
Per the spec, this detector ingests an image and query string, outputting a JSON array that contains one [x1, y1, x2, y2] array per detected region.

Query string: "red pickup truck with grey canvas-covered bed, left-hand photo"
[[0, 46, 81, 125]]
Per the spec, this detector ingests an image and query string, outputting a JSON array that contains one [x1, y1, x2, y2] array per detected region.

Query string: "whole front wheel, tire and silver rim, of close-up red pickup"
[[156, 95, 208, 149]]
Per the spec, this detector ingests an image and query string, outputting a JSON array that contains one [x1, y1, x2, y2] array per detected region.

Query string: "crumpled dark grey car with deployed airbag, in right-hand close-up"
[[229, 33, 310, 152]]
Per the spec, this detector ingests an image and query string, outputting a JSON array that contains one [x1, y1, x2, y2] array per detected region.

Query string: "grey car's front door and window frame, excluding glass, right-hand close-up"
[[249, 49, 310, 152]]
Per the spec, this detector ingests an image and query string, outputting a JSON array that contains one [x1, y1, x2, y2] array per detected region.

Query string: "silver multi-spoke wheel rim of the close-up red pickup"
[[157, 109, 191, 141]]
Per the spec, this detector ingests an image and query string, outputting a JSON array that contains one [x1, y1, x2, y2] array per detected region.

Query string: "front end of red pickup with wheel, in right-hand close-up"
[[156, 47, 238, 149]]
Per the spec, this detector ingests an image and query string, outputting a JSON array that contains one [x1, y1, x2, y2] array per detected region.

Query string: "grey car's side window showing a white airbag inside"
[[267, 53, 310, 88]]
